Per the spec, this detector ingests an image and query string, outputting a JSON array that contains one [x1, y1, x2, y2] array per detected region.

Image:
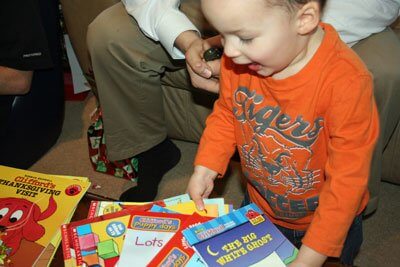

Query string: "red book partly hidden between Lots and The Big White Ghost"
[[147, 213, 213, 267]]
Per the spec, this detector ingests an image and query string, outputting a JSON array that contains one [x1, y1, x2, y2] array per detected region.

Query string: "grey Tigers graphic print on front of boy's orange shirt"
[[233, 87, 323, 217]]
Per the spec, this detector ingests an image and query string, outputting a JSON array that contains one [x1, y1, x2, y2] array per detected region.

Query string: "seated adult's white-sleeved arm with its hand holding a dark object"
[[122, 0, 220, 93]]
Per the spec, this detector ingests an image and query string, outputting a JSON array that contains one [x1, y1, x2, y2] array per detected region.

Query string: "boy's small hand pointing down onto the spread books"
[[186, 165, 218, 211]]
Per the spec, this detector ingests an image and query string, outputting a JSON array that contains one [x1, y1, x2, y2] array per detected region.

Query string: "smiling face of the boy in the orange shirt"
[[202, 0, 301, 76]]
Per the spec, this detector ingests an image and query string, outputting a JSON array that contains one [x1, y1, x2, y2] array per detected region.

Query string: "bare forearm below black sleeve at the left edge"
[[0, 66, 33, 95]]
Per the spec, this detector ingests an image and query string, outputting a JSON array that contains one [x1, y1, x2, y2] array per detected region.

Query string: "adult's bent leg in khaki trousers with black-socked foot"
[[87, 3, 184, 201]]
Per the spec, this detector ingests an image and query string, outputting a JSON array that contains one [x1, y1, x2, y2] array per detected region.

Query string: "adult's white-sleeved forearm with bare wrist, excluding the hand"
[[122, 0, 200, 59]]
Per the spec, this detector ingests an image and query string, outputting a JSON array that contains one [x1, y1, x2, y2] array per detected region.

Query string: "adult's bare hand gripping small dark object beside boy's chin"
[[185, 36, 221, 93]]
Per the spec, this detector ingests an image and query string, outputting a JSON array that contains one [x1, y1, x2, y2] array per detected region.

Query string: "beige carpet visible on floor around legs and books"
[[31, 93, 400, 267]]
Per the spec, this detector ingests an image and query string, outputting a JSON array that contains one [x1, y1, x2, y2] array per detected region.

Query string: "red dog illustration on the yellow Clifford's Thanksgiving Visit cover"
[[0, 196, 57, 256]]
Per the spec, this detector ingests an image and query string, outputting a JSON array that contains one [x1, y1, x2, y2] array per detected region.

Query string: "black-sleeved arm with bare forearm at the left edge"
[[0, 0, 52, 95]]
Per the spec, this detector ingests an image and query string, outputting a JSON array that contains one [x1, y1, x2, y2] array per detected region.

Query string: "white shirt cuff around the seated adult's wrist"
[[156, 10, 200, 59]]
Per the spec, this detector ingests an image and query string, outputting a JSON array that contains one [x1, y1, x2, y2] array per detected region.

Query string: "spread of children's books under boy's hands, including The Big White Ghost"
[[62, 194, 298, 267]]
